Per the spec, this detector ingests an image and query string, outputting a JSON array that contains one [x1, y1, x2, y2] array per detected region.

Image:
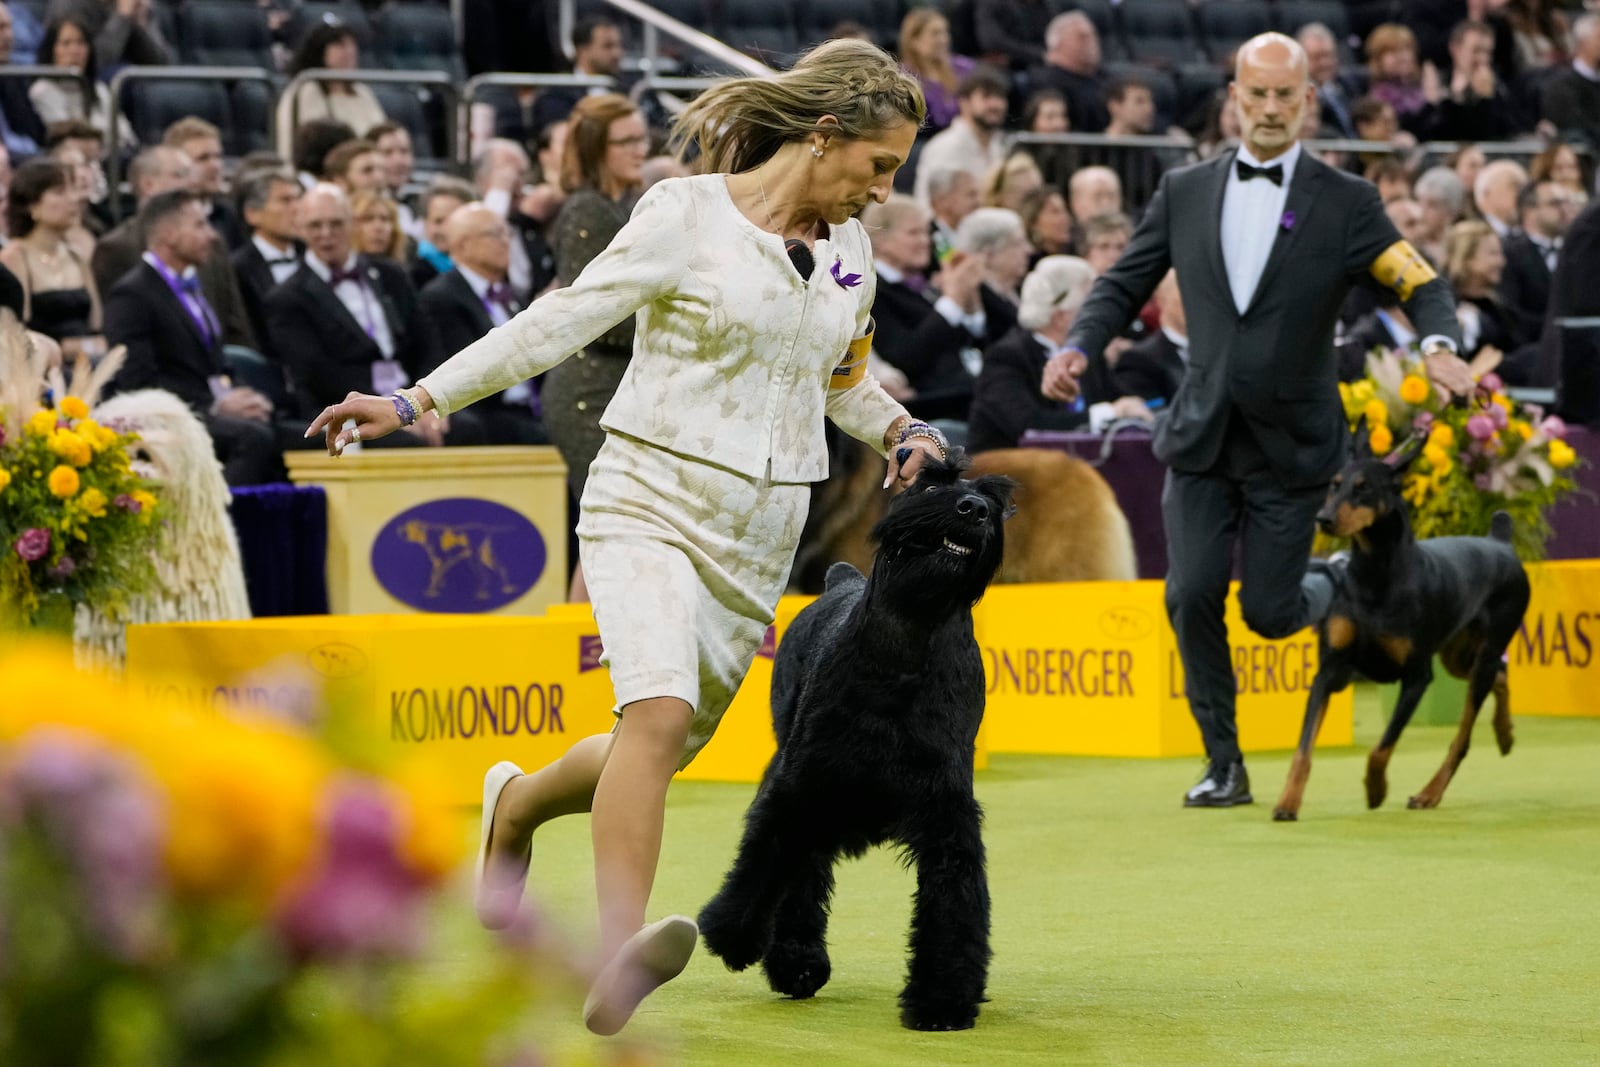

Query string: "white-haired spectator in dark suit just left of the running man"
[[966, 256, 1150, 453]]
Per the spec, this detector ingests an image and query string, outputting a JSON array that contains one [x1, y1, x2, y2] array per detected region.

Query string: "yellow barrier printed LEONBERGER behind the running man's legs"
[[974, 581, 1354, 757]]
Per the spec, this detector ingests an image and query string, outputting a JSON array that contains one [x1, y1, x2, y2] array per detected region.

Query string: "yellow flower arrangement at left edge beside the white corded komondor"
[[0, 314, 162, 629]]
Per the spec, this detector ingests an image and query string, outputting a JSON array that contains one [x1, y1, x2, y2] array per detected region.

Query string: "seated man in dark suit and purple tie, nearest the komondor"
[[106, 189, 285, 485]]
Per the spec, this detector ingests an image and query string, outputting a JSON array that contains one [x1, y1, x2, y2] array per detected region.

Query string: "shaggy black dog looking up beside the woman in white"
[[699, 456, 1011, 1030]]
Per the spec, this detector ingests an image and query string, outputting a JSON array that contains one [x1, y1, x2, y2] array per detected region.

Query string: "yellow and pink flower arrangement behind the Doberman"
[[1339, 350, 1578, 560]]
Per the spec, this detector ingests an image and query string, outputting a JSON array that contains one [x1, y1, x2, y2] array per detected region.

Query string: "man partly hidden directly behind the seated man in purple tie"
[[90, 146, 258, 349]]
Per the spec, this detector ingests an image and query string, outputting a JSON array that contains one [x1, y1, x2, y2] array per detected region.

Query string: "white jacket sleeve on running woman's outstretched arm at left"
[[418, 182, 696, 414]]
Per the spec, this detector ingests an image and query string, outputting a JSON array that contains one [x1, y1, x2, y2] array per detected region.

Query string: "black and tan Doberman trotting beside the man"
[[1272, 438, 1528, 822]]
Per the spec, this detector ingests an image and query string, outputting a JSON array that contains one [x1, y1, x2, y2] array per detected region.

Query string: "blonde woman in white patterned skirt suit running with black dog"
[[307, 40, 944, 1033]]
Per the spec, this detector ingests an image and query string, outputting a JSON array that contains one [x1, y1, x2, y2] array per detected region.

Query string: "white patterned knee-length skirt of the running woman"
[[578, 432, 811, 769]]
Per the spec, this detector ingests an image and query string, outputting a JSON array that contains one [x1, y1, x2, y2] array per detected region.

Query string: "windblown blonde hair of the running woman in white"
[[672, 38, 928, 174]]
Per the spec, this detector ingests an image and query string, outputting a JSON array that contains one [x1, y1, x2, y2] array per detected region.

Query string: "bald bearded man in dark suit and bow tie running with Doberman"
[[1043, 34, 1472, 808]]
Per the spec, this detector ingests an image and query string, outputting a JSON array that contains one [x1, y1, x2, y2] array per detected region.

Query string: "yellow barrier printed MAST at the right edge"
[[1507, 560, 1600, 717]]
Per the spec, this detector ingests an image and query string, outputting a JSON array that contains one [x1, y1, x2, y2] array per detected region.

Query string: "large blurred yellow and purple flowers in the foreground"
[[0, 640, 604, 1067]]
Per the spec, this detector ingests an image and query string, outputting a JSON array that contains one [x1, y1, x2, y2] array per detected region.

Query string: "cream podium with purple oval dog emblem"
[[285, 446, 566, 614]]
